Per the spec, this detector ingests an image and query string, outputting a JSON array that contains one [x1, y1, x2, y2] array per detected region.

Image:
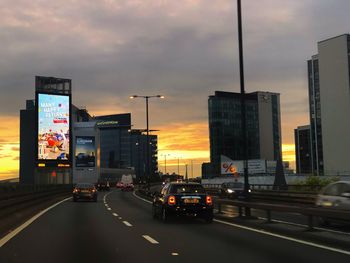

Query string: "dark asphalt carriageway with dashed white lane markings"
[[0, 190, 350, 263]]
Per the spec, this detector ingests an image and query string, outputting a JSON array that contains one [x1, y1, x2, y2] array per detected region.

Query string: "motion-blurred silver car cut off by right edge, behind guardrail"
[[316, 181, 350, 225]]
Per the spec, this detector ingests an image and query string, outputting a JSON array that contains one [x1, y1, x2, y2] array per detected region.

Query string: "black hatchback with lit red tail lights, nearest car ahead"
[[152, 182, 213, 223]]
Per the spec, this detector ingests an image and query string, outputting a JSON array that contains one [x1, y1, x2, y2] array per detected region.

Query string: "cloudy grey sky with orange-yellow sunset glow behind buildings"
[[0, 0, 350, 178]]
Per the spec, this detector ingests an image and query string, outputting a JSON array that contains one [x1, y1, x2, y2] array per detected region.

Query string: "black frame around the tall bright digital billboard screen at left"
[[34, 90, 73, 168]]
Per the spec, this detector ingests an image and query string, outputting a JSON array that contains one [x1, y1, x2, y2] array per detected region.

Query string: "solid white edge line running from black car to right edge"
[[214, 219, 350, 255]]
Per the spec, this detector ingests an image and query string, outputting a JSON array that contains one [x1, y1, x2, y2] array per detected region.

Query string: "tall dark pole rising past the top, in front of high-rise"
[[237, 0, 249, 200]]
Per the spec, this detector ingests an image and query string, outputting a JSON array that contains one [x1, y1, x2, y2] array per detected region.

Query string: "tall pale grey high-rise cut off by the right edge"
[[308, 34, 350, 175]]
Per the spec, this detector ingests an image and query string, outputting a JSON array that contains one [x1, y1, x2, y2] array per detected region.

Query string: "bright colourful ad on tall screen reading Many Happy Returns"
[[37, 94, 70, 160]]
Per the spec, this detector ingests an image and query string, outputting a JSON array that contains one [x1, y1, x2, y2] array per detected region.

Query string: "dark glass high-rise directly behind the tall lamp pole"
[[208, 91, 281, 177]]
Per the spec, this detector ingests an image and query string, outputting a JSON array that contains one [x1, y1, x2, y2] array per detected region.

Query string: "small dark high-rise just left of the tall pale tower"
[[294, 125, 312, 174]]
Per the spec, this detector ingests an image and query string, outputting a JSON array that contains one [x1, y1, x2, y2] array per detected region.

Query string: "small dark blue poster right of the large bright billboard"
[[75, 136, 96, 167]]
